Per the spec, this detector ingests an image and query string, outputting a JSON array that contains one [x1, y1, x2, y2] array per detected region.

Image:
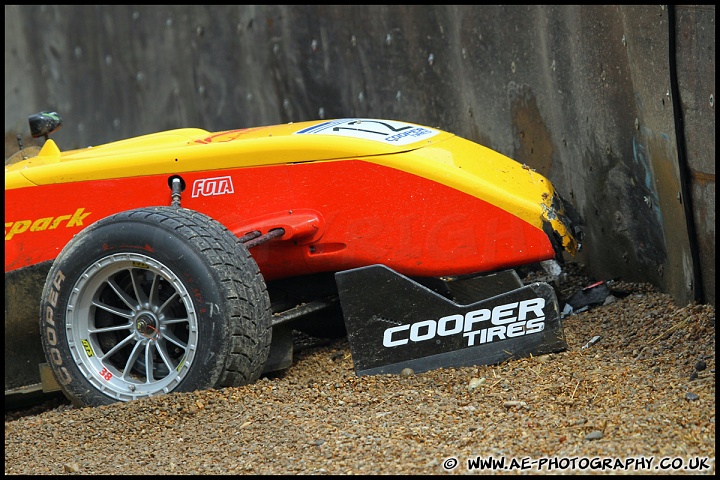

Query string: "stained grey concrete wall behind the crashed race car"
[[5, 5, 715, 305]]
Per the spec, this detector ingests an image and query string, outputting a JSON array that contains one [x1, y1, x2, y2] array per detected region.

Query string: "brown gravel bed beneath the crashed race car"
[[5, 264, 715, 475]]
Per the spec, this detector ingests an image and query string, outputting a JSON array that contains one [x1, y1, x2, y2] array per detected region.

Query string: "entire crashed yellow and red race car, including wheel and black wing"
[[5, 112, 580, 406]]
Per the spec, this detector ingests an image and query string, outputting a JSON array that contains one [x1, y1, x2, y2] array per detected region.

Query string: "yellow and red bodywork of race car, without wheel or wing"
[[5, 119, 578, 280]]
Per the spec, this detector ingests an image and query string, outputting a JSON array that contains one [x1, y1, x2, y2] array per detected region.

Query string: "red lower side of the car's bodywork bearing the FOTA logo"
[[5, 160, 555, 280]]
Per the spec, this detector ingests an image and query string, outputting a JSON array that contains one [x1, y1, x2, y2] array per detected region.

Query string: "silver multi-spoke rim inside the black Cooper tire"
[[66, 253, 198, 400]]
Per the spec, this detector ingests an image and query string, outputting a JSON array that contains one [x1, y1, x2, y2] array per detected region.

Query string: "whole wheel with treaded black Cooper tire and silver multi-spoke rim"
[[40, 207, 272, 406]]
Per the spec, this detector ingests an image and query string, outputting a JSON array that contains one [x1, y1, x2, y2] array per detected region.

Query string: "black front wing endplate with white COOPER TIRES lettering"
[[335, 265, 567, 375]]
